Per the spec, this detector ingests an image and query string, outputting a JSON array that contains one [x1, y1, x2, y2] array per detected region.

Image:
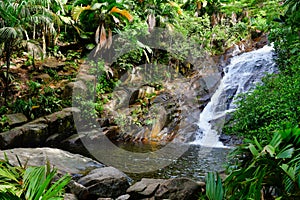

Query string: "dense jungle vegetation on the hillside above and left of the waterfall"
[[0, 0, 278, 131]]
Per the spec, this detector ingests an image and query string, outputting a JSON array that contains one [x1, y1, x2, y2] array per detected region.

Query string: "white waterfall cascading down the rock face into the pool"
[[191, 46, 276, 147]]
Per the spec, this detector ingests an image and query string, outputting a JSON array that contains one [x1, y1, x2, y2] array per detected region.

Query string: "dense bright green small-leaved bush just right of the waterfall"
[[223, 71, 300, 139]]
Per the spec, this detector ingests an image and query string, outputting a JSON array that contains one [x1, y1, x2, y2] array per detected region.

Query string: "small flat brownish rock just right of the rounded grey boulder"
[[127, 178, 166, 199]]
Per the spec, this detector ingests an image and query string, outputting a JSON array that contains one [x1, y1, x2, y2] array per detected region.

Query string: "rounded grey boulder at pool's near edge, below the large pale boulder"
[[78, 167, 130, 199]]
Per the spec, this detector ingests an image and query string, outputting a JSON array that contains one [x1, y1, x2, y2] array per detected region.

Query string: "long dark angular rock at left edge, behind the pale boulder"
[[0, 108, 79, 149]]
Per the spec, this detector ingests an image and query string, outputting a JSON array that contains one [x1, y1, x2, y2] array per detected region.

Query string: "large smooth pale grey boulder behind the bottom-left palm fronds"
[[0, 148, 104, 177]]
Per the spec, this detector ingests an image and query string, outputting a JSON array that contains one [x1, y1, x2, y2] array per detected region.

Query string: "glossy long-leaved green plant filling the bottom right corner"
[[224, 128, 300, 199]]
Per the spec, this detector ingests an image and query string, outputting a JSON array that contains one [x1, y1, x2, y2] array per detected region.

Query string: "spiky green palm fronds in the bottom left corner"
[[0, 155, 71, 200]]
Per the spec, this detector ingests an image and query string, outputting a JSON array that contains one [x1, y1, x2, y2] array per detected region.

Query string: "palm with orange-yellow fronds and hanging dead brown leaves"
[[72, 0, 133, 52]]
